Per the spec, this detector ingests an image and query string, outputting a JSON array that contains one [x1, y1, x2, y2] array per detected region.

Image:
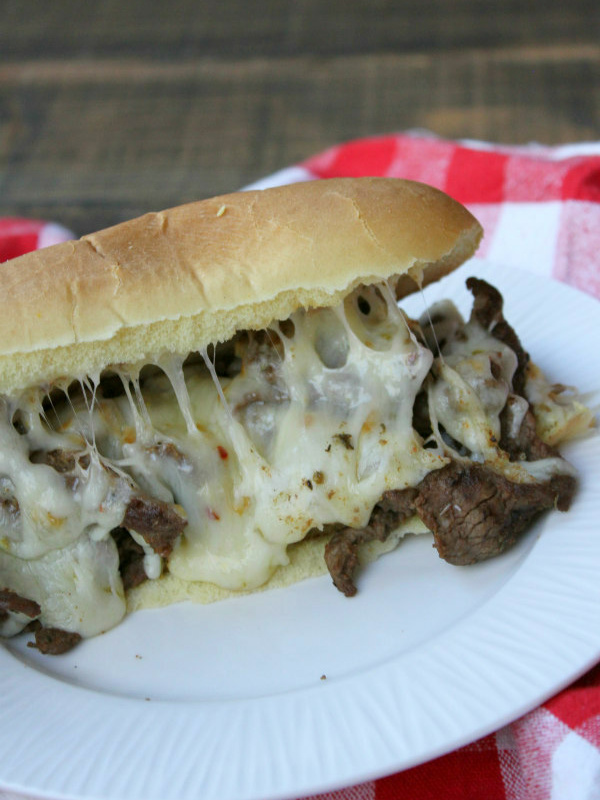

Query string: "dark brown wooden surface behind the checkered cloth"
[[0, 0, 600, 234]]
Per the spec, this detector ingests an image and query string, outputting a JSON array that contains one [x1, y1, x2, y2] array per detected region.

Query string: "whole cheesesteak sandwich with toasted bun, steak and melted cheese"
[[0, 178, 590, 653]]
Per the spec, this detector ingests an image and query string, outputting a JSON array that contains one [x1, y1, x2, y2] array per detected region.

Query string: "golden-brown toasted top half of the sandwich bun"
[[0, 178, 482, 393]]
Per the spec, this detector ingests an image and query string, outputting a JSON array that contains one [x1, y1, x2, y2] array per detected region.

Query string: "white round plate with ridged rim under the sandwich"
[[0, 262, 600, 800]]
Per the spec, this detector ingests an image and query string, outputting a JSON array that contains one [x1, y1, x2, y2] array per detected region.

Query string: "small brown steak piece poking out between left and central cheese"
[[122, 495, 187, 558]]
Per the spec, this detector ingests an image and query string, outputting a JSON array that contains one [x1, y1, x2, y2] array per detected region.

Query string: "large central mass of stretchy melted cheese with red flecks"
[[85, 289, 440, 590]]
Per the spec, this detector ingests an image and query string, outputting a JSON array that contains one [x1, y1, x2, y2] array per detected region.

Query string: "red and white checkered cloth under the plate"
[[0, 133, 600, 800]]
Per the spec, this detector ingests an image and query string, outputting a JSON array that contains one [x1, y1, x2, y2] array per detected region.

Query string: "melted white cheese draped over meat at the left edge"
[[0, 391, 132, 636]]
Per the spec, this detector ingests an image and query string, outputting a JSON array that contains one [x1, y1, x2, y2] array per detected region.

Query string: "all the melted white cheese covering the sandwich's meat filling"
[[0, 284, 580, 636]]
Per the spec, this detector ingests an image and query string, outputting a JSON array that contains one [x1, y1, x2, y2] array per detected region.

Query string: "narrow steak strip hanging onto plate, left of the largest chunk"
[[325, 488, 417, 597]]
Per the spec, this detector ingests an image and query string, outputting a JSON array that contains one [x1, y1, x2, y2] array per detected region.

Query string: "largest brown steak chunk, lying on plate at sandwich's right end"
[[415, 462, 575, 565]]
